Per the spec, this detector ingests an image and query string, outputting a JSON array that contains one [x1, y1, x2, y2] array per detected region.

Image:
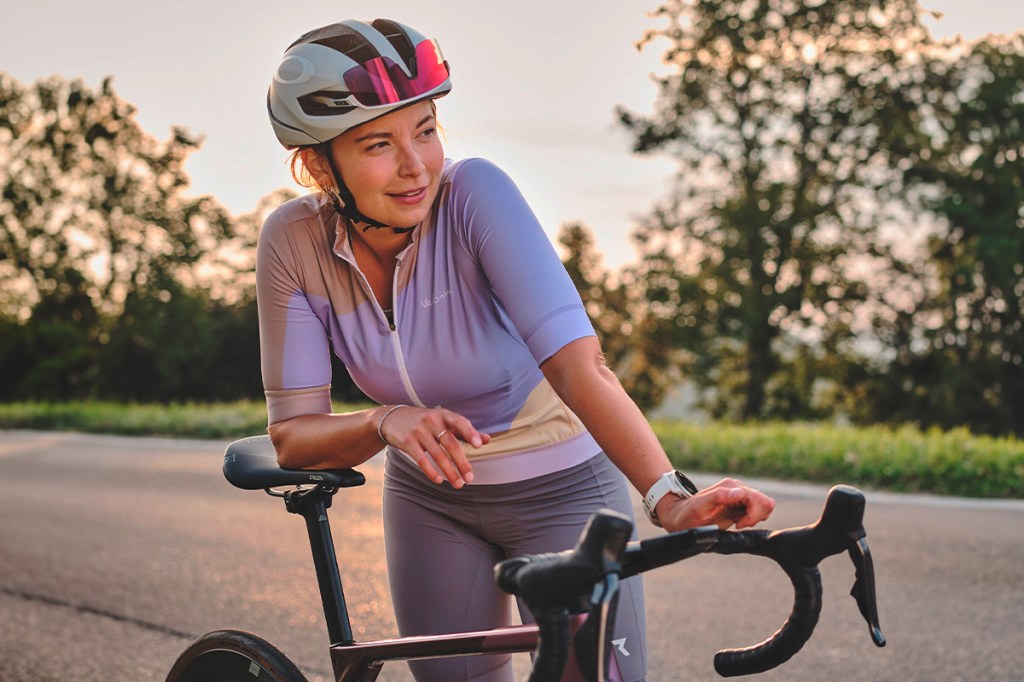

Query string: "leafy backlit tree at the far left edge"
[[0, 74, 233, 398]]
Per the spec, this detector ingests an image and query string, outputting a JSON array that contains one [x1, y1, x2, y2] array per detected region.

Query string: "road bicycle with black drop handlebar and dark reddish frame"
[[167, 436, 886, 682]]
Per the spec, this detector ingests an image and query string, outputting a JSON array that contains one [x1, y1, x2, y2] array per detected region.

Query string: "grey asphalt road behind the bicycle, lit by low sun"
[[0, 431, 1024, 682]]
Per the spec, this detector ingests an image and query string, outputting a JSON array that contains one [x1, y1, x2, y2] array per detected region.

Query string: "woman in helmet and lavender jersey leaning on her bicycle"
[[257, 19, 773, 682]]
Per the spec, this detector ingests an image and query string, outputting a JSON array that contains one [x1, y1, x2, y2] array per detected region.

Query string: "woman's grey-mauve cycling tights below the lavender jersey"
[[384, 453, 647, 682]]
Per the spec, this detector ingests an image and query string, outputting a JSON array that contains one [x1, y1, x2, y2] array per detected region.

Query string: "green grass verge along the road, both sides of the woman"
[[0, 400, 1024, 499]]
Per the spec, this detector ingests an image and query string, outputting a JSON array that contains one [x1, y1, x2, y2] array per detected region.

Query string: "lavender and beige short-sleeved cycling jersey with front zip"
[[256, 159, 599, 483]]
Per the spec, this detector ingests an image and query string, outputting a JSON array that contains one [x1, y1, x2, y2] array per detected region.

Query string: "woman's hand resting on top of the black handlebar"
[[655, 478, 775, 532]]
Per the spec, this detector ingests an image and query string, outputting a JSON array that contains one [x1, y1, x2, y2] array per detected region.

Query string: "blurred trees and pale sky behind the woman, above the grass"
[[0, 0, 1024, 436]]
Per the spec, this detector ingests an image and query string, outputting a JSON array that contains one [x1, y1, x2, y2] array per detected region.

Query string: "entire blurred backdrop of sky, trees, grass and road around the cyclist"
[[0, 0, 1024, 681]]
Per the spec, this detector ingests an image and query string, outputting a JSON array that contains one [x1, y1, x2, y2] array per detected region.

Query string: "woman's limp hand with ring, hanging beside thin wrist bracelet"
[[378, 406, 490, 488]]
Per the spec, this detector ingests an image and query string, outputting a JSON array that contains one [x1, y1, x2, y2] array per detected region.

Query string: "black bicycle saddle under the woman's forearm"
[[224, 435, 367, 491]]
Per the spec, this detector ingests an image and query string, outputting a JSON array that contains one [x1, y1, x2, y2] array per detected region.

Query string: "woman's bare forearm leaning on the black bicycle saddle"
[[267, 408, 393, 469]]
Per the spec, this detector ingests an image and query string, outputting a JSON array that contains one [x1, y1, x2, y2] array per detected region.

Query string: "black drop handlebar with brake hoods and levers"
[[495, 485, 886, 682]]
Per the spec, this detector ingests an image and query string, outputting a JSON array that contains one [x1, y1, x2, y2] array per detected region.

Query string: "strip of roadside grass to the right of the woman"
[[654, 422, 1024, 498]]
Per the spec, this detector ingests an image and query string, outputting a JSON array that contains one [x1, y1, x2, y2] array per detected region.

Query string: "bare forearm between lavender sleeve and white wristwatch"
[[541, 337, 672, 495]]
